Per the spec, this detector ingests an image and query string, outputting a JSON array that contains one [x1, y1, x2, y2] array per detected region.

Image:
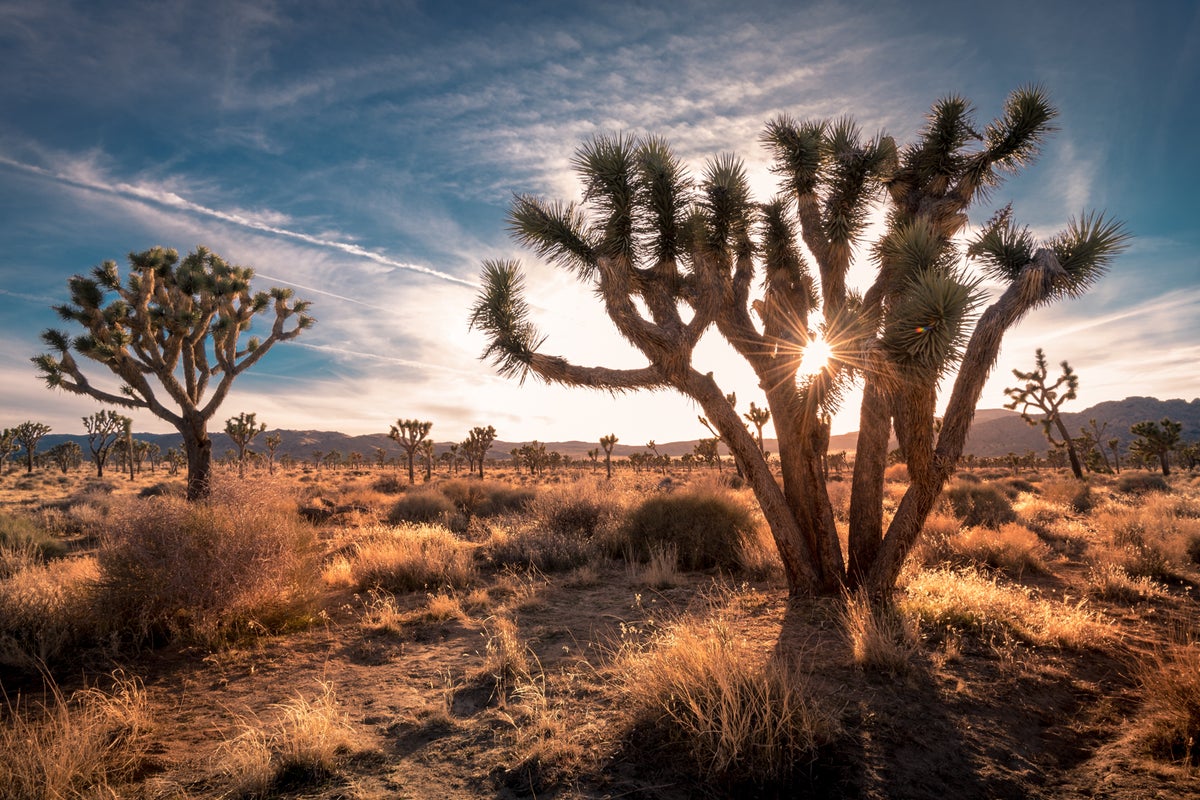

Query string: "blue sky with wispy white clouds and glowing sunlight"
[[0, 0, 1200, 444]]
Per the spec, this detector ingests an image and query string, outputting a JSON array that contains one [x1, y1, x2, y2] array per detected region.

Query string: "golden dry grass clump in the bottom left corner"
[[0, 673, 152, 800]]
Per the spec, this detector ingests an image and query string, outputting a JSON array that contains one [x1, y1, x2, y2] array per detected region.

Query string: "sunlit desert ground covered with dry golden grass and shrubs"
[[0, 458, 1200, 799]]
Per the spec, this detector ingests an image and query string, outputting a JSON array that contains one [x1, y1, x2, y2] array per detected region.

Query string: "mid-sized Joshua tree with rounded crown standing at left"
[[34, 247, 313, 500]]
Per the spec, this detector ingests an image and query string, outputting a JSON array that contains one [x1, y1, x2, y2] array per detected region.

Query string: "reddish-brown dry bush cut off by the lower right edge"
[[1135, 643, 1200, 768]]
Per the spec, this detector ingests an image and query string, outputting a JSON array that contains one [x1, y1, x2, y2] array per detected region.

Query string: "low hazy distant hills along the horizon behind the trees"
[[30, 397, 1200, 461]]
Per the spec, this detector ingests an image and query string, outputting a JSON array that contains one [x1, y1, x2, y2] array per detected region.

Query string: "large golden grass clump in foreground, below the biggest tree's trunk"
[[617, 616, 839, 784]]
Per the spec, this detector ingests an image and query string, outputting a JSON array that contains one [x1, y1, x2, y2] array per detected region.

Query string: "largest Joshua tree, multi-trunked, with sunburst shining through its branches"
[[472, 88, 1126, 594]]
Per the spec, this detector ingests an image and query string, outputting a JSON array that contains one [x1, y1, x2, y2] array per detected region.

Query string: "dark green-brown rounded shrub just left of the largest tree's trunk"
[[623, 488, 755, 570]]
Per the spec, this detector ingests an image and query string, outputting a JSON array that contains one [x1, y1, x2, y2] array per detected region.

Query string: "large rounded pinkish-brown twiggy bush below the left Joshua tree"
[[98, 482, 318, 643]]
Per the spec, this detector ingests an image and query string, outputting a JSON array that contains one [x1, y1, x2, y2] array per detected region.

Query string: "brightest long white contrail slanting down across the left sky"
[[0, 156, 479, 289]]
